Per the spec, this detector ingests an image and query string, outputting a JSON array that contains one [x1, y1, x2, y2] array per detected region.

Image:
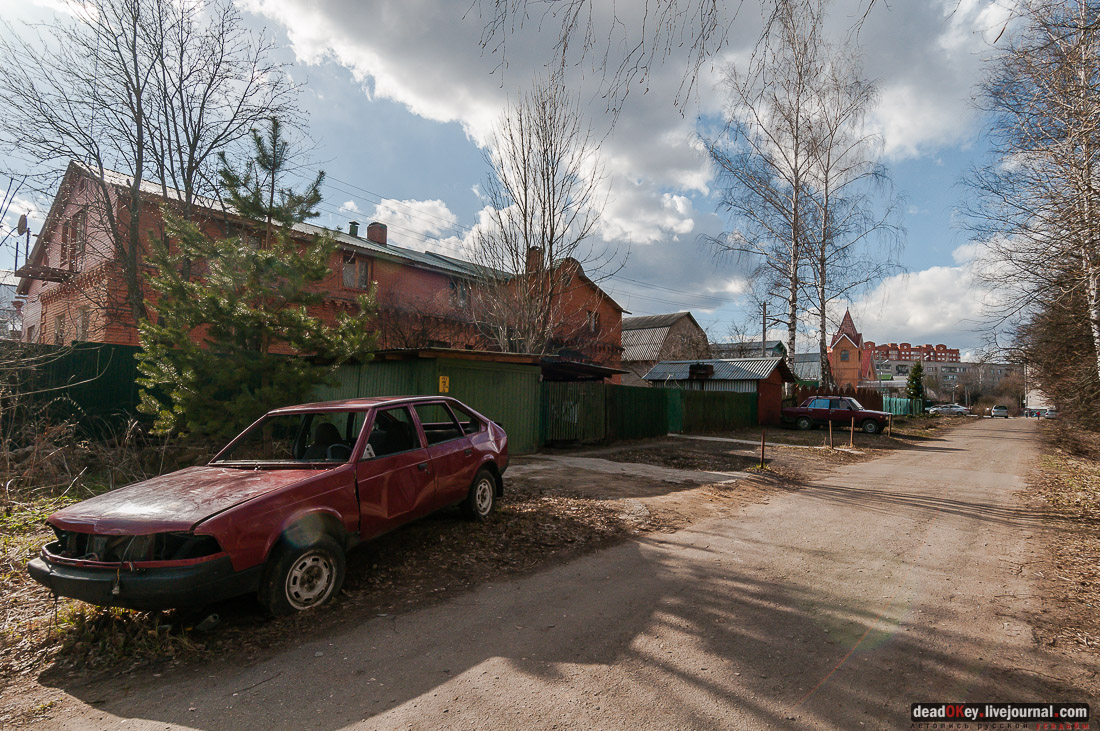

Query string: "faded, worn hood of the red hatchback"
[[48, 466, 317, 535]]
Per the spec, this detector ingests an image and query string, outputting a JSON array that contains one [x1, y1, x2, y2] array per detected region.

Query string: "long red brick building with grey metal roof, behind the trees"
[[17, 163, 624, 367]]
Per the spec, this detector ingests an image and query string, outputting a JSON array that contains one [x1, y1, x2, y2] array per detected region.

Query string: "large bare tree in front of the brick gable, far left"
[[0, 0, 292, 321]]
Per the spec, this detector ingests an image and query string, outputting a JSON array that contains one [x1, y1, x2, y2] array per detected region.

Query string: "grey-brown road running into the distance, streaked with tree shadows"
[[40, 420, 1097, 729]]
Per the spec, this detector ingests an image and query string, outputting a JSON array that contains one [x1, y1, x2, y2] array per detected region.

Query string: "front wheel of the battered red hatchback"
[[260, 535, 345, 617]]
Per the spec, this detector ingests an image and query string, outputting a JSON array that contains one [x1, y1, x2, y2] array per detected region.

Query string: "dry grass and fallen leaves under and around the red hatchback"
[[0, 480, 638, 699]]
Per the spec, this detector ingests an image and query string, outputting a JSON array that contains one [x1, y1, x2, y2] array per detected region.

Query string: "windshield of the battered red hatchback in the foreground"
[[215, 411, 366, 464]]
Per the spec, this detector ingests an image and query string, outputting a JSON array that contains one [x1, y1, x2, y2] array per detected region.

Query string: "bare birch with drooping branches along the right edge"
[[969, 0, 1100, 399]]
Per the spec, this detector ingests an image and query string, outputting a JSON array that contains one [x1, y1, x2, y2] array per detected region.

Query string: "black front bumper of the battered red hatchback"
[[26, 555, 263, 610]]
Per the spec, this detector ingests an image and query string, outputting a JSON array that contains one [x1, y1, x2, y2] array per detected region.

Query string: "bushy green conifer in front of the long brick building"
[[138, 119, 375, 439]]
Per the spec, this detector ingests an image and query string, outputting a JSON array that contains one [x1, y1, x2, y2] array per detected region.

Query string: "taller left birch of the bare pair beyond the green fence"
[[705, 2, 825, 362]]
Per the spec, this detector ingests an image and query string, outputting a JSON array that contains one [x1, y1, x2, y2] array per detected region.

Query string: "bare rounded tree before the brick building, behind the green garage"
[[470, 76, 617, 353]]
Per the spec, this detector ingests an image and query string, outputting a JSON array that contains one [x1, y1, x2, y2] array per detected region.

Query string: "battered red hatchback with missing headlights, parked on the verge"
[[28, 397, 508, 614]]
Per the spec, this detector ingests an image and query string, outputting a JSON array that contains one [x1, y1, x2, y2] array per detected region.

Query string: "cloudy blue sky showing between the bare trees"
[[0, 0, 1007, 350]]
